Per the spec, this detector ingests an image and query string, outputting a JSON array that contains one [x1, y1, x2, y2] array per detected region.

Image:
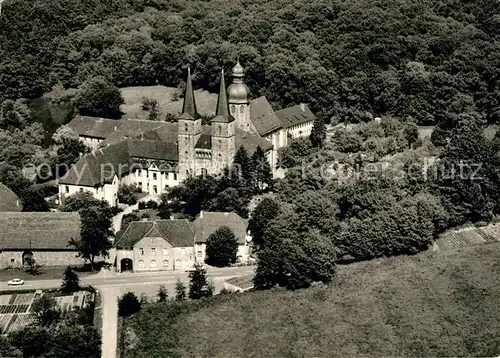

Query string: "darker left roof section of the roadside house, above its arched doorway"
[[114, 219, 194, 249]]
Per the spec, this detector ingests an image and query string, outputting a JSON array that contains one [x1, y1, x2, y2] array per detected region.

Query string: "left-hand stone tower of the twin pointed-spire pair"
[[177, 67, 202, 180]]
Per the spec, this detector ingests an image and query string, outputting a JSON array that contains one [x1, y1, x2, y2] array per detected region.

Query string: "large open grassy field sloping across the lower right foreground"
[[120, 244, 500, 357]]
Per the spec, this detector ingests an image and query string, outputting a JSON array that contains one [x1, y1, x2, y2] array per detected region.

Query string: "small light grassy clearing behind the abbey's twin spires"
[[120, 86, 217, 120]]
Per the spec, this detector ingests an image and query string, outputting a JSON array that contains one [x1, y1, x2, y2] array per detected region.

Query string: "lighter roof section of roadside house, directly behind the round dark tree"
[[193, 211, 247, 245]]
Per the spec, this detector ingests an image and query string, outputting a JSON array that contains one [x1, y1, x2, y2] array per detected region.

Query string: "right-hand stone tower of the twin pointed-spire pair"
[[211, 70, 236, 173]]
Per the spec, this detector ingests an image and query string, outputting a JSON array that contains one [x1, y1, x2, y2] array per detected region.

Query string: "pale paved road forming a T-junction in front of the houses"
[[0, 266, 254, 358]]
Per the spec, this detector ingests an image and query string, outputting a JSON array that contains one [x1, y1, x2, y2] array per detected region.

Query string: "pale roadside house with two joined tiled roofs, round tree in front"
[[113, 211, 251, 272]]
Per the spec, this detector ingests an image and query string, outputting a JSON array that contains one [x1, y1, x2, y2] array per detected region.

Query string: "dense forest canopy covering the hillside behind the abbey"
[[0, 0, 500, 129]]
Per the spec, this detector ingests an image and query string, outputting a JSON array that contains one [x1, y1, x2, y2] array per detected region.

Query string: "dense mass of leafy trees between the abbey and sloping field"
[[254, 114, 500, 288]]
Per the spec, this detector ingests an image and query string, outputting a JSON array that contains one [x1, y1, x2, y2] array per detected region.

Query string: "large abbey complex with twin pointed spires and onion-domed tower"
[[59, 62, 315, 205]]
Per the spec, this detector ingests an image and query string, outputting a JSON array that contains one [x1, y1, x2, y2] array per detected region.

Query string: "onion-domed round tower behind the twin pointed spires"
[[227, 60, 255, 132]]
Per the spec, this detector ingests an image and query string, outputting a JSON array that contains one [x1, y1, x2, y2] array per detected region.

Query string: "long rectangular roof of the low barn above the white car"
[[0, 212, 80, 251]]
